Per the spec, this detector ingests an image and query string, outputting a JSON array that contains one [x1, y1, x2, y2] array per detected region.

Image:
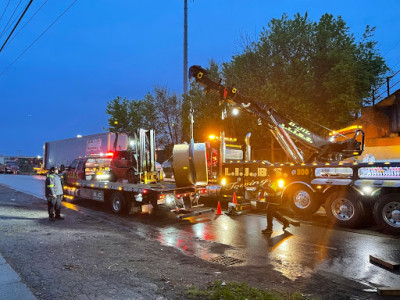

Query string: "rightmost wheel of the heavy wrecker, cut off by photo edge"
[[374, 193, 400, 234]]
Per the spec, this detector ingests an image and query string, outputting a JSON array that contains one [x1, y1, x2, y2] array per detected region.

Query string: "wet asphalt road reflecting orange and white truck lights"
[[0, 175, 400, 288]]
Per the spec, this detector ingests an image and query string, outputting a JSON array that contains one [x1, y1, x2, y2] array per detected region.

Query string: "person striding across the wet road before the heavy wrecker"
[[261, 182, 290, 234]]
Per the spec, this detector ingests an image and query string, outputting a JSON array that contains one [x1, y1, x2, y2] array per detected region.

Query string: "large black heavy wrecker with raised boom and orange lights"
[[189, 65, 400, 234]]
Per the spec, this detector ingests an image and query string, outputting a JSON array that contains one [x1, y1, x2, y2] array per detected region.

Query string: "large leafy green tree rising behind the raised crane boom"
[[223, 14, 387, 137]]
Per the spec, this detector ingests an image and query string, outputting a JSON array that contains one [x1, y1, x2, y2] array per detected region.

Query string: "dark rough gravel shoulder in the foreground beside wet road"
[[0, 185, 387, 299]]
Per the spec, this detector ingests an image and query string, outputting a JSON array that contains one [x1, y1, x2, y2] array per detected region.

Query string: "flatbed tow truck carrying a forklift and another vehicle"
[[62, 129, 212, 219]]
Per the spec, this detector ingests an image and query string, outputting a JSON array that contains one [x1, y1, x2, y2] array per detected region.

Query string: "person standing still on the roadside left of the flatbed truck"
[[46, 167, 64, 221]]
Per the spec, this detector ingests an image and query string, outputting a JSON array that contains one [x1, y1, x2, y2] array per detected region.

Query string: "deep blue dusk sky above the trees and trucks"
[[0, 0, 400, 156]]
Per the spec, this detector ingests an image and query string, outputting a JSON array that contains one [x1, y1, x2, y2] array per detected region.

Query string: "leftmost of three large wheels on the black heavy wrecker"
[[289, 185, 321, 216]]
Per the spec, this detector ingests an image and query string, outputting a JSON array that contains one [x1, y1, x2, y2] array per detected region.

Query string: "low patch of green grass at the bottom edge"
[[185, 281, 306, 300]]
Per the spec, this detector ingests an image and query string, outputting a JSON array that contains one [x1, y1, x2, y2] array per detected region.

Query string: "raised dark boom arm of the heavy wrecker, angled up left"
[[189, 66, 364, 163]]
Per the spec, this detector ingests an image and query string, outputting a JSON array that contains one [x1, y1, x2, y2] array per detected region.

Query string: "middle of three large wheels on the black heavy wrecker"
[[325, 191, 365, 228]]
